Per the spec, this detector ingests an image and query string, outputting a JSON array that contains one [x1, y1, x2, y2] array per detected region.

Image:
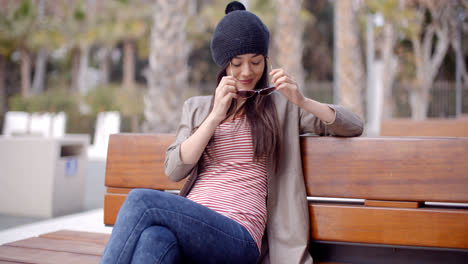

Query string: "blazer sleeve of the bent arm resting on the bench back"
[[299, 104, 364, 137]]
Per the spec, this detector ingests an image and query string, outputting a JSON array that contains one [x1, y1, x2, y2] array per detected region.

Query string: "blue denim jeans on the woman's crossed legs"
[[101, 189, 259, 264]]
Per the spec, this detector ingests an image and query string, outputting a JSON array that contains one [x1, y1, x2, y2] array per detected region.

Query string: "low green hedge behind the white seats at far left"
[[9, 89, 78, 113]]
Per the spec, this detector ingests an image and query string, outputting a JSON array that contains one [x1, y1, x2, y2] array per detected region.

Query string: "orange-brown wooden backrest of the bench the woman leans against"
[[104, 134, 468, 263]]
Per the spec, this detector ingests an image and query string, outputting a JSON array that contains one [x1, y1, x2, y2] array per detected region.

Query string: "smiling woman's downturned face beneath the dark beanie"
[[226, 53, 265, 90]]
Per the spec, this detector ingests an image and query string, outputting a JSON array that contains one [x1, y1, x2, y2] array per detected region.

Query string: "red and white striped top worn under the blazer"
[[187, 116, 267, 249]]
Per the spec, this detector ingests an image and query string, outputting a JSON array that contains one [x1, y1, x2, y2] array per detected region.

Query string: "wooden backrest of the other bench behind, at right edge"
[[380, 119, 468, 137]]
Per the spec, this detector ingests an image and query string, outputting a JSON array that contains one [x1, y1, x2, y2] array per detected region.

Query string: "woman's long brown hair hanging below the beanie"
[[210, 57, 282, 170]]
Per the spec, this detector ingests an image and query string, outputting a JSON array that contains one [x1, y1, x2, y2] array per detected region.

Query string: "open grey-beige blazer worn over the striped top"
[[165, 93, 363, 263]]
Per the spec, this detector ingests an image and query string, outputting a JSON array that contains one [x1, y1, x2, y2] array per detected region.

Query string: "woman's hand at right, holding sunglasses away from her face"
[[270, 68, 305, 106]]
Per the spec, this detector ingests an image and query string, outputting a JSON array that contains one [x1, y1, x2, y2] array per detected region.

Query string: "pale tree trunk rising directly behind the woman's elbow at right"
[[335, 1, 365, 117]]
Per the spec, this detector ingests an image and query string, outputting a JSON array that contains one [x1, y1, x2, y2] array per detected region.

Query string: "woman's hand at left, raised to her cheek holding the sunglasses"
[[210, 76, 237, 122]]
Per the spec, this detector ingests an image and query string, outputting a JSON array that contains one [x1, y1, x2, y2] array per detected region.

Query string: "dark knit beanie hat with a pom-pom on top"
[[211, 1, 270, 66]]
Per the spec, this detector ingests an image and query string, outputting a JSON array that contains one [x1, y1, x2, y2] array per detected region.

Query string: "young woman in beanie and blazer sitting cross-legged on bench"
[[102, 2, 363, 263]]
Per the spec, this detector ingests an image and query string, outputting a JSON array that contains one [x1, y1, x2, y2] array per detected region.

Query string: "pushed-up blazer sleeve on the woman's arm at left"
[[164, 99, 196, 181]]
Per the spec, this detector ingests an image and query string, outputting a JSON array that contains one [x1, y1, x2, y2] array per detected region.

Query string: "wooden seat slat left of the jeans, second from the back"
[[5, 237, 106, 256]]
